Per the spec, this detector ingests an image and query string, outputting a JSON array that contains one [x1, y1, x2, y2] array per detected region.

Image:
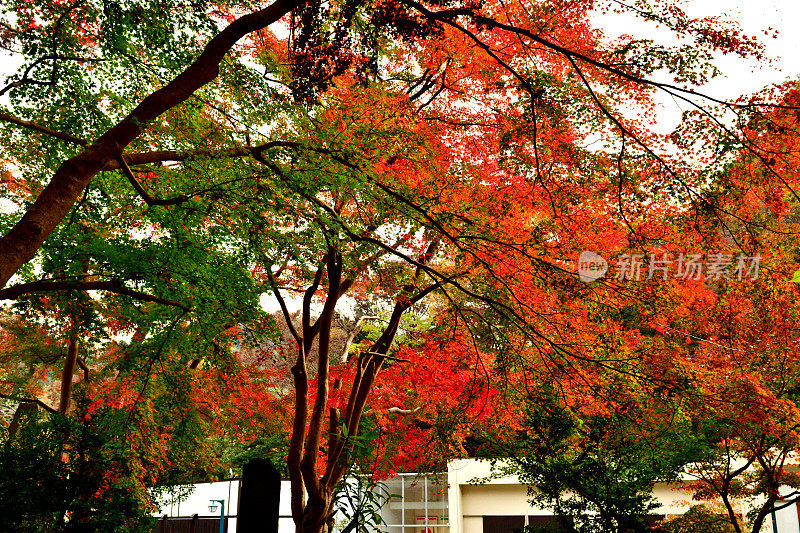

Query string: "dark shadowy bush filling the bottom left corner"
[[0, 414, 154, 533]]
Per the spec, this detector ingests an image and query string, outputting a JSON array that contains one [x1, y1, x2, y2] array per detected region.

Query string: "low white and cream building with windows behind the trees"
[[155, 459, 800, 533]]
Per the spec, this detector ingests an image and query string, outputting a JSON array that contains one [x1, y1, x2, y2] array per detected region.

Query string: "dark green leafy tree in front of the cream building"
[[509, 390, 698, 533]]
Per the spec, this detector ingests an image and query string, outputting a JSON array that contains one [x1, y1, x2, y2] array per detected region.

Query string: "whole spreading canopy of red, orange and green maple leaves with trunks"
[[0, 0, 798, 532]]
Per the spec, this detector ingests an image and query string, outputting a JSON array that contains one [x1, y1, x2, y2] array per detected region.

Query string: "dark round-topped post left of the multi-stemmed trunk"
[[236, 459, 281, 533]]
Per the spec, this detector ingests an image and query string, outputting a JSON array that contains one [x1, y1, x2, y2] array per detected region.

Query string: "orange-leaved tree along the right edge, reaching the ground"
[[652, 87, 800, 531]]
